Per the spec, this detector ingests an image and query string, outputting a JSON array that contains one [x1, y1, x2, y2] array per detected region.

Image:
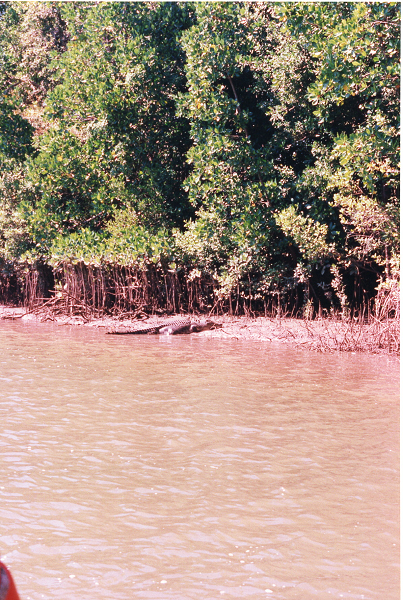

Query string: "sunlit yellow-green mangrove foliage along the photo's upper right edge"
[[282, 2, 400, 276]]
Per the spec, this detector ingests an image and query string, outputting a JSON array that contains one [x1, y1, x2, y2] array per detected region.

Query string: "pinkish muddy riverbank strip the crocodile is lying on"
[[0, 306, 400, 355]]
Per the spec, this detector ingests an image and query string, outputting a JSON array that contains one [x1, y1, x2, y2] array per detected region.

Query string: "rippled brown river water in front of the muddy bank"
[[0, 322, 399, 600]]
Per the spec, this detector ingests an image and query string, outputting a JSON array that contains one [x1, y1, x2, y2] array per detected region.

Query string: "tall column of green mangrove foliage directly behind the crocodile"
[[178, 3, 331, 294]]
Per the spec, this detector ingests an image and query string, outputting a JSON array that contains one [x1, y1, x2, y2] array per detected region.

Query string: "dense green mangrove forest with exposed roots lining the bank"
[[0, 1, 400, 318]]
